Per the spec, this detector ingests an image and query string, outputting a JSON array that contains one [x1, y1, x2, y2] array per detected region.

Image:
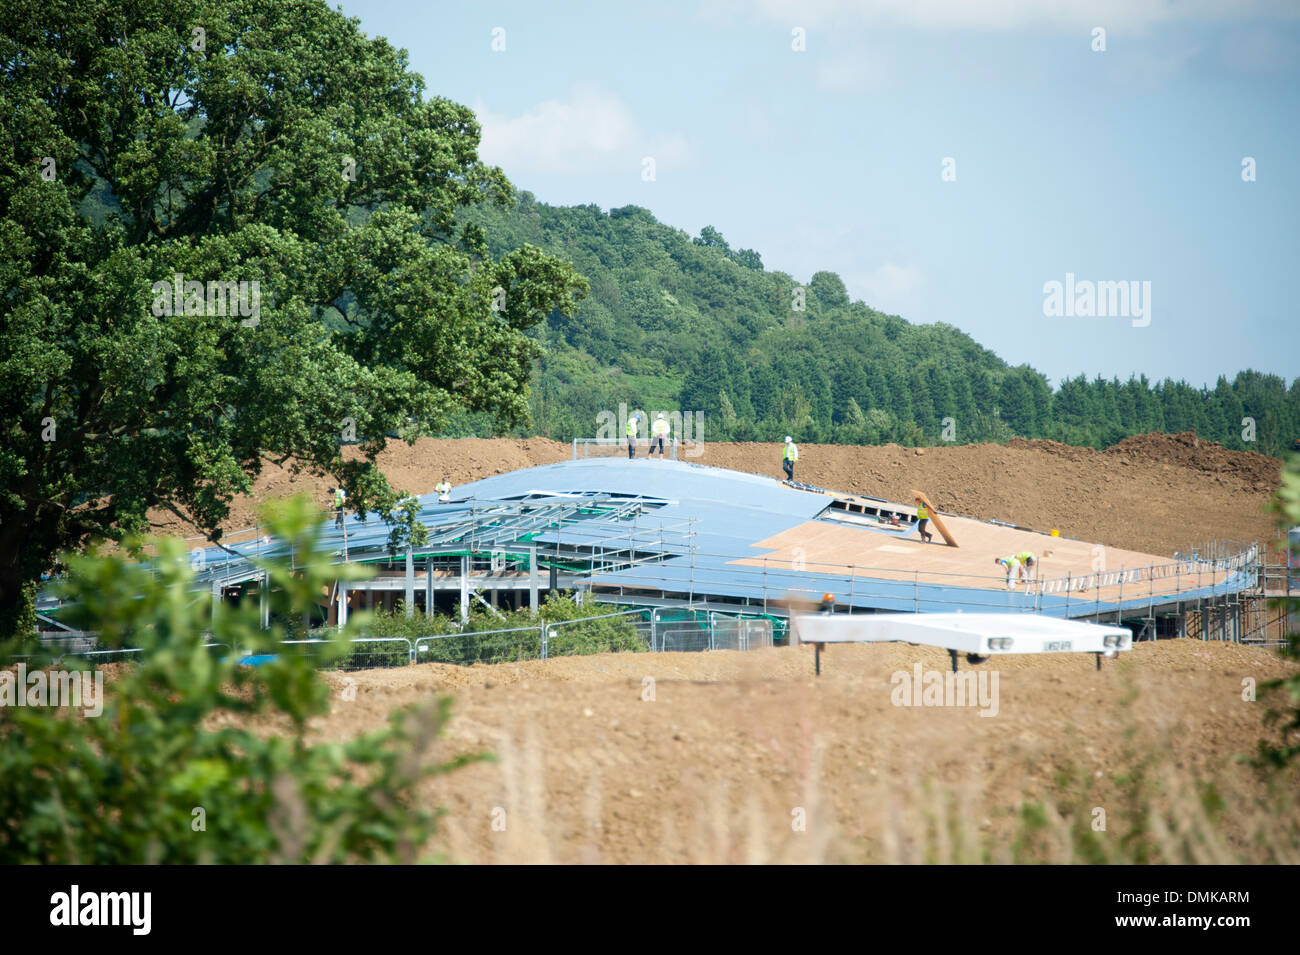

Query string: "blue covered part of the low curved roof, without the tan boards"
[[81, 457, 1243, 616]]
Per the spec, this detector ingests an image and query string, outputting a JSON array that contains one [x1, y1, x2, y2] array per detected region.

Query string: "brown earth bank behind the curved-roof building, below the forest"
[[153, 434, 1281, 556]]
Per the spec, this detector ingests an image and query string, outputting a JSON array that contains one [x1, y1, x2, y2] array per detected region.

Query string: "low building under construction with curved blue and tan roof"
[[137, 457, 1284, 642]]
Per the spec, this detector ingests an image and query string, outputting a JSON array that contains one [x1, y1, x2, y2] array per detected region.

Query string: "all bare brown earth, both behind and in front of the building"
[[172, 435, 1300, 863]]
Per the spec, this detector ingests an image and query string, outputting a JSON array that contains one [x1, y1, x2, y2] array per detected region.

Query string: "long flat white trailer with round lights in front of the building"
[[790, 613, 1132, 673]]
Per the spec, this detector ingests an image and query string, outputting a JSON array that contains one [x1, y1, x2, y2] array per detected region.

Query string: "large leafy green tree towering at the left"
[[0, 0, 585, 641]]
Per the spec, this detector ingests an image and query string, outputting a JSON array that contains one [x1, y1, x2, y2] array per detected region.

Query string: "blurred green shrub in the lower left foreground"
[[0, 499, 486, 864]]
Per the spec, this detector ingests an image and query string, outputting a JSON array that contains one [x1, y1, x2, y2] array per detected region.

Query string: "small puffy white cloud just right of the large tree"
[[475, 86, 690, 175]]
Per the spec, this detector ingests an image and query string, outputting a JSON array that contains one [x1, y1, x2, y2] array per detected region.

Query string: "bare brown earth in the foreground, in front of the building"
[[312, 641, 1300, 863]]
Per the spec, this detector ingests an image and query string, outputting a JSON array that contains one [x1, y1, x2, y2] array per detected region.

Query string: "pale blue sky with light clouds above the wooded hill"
[[332, 0, 1300, 385]]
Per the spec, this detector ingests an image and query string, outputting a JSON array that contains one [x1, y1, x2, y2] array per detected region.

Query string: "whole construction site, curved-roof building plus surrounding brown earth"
[[25, 435, 1300, 863]]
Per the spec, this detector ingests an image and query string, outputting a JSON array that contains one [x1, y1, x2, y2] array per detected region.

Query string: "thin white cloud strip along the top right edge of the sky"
[[701, 0, 1300, 33]]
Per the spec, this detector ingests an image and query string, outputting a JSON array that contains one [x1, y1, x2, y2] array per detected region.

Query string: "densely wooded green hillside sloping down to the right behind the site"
[[449, 192, 1300, 455]]
